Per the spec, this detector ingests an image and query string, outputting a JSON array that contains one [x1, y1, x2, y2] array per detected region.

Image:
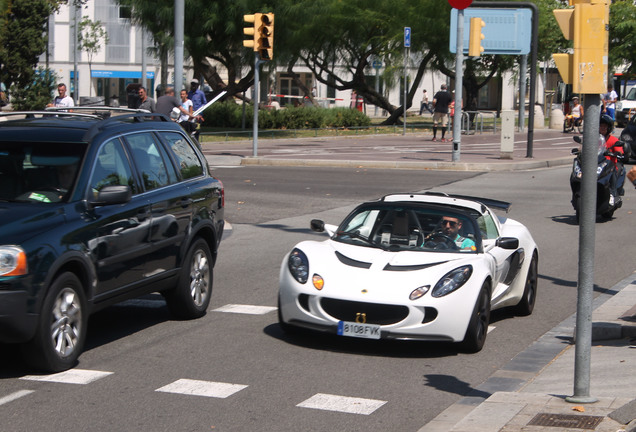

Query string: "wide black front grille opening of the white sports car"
[[320, 298, 409, 325]]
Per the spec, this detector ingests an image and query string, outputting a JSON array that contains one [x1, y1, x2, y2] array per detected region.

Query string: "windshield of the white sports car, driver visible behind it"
[[333, 203, 481, 253]]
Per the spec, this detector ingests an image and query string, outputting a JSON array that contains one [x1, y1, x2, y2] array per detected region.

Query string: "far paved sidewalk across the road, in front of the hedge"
[[202, 129, 578, 171]]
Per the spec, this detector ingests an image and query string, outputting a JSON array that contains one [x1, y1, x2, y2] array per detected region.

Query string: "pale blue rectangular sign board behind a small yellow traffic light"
[[449, 7, 532, 55]]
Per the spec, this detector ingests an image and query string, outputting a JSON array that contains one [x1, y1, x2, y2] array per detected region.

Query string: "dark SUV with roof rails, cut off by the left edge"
[[0, 108, 224, 372]]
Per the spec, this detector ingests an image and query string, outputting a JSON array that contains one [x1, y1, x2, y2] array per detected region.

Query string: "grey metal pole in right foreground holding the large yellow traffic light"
[[566, 93, 601, 403]]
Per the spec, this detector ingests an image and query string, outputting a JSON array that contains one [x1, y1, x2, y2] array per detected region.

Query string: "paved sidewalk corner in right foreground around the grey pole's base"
[[419, 274, 636, 432]]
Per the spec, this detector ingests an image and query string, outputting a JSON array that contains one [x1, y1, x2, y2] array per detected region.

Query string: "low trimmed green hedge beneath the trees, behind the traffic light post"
[[203, 102, 371, 129]]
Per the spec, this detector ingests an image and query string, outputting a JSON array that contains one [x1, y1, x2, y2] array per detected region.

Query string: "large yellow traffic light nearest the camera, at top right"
[[552, 0, 609, 94]]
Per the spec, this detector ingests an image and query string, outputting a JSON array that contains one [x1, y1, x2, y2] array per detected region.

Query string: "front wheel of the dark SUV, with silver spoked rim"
[[23, 273, 87, 372]]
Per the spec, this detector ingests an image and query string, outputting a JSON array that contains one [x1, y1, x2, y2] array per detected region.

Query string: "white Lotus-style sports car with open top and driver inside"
[[278, 192, 539, 352]]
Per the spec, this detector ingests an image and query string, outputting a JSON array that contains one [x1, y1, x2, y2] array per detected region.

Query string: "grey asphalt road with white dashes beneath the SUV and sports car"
[[0, 167, 636, 432]]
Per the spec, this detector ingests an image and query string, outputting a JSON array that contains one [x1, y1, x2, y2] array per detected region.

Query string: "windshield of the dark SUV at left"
[[0, 142, 85, 203]]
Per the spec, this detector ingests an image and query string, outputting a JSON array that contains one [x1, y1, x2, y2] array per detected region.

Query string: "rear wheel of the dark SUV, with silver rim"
[[164, 238, 213, 319]]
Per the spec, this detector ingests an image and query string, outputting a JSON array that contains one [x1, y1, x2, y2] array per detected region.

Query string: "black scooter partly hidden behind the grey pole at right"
[[570, 136, 625, 224]]
